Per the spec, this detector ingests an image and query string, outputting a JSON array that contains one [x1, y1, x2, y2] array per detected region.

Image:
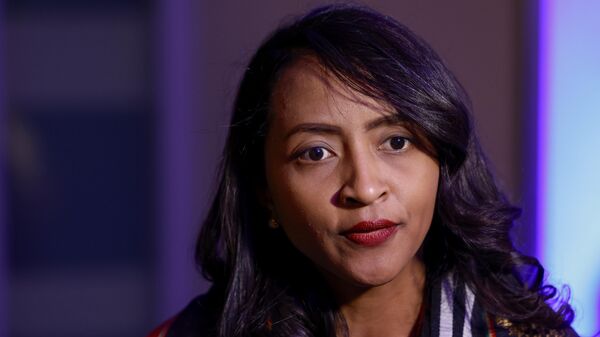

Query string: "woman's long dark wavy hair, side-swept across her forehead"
[[196, 5, 573, 337]]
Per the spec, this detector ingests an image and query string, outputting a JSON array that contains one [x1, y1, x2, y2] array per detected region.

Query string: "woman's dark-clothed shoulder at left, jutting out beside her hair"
[[147, 293, 218, 337]]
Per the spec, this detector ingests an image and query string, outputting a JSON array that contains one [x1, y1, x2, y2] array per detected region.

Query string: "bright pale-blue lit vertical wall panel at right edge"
[[537, 0, 600, 336]]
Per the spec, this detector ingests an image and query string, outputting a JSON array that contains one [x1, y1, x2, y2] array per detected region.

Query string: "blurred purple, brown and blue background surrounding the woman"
[[0, 0, 600, 337]]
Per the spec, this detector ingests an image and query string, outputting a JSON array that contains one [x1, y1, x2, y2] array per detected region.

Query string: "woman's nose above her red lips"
[[337, 151, 389, 207]]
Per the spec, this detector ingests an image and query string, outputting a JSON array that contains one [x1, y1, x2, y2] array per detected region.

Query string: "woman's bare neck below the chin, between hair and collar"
[[334, 260, 425, 337]]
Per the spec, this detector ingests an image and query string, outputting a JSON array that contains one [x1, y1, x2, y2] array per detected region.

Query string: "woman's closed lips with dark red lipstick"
[[342, 219, 398, 247]]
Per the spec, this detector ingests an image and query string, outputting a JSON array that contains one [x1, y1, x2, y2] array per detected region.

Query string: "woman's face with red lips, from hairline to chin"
[[265, 59, 439, 287]]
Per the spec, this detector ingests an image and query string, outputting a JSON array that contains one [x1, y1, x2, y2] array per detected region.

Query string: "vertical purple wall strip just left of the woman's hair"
[[156, 0, 213, 320]]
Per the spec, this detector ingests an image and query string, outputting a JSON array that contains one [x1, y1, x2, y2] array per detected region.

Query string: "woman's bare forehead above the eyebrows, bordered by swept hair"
[[270, 57, 394, 126]]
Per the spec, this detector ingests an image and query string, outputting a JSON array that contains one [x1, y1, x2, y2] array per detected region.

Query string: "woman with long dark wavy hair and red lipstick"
[[148, 5, 575, 337]]
